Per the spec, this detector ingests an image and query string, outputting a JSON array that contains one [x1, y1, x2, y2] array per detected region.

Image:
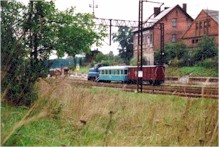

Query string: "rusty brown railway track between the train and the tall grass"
[[66, 80, 218, 99]]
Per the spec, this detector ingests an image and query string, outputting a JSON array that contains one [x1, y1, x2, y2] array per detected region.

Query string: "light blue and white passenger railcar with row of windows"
[[98, 66, 129, 82]]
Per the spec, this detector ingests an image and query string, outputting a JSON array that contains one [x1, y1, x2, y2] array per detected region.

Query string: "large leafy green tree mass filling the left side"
[[1, 1, 105, 105]]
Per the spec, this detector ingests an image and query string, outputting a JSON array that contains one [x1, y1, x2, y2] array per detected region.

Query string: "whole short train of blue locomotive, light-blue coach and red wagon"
[[88, 65, 165, 85]]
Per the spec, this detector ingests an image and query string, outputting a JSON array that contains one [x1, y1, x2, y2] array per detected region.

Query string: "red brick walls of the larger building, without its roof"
[[134, 6, 193, 65]]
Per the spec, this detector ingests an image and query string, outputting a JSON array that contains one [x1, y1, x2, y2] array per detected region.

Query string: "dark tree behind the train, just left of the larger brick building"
[[113, 27, 134, 64]]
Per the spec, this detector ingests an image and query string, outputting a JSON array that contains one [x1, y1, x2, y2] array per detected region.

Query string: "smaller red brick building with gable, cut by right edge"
[[182, 10, 219, 48]]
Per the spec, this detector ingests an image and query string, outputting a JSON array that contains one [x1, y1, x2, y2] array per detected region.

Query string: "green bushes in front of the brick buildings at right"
[[155, 36, 218, 67]]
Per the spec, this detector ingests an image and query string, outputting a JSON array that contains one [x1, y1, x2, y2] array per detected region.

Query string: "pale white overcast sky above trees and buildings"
[[19, 0, 219, 55]]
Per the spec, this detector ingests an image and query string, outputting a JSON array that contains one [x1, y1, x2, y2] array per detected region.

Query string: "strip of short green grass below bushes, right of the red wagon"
[[166, 66, 218, 77]]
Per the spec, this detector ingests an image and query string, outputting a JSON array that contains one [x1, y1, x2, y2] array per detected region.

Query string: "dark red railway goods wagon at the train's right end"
[[128, 65, 165, 85]]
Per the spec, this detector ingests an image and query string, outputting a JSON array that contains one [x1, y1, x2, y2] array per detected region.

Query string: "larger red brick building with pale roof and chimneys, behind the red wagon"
[[134, 4, 193, 65]]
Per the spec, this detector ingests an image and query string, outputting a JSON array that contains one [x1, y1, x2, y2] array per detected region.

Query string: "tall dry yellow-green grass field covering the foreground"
[[2, 79, 218, 146]]
